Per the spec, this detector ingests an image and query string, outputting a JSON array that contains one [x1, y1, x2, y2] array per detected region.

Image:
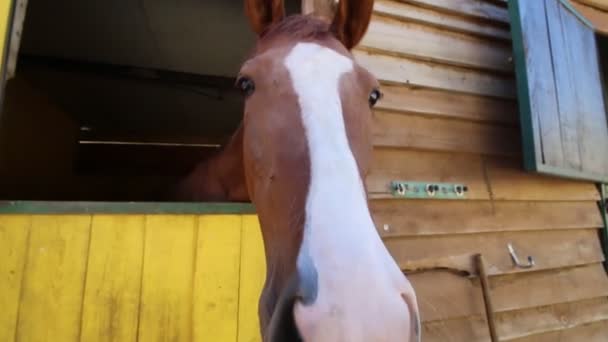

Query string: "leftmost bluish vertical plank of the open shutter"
[[509, 0, 564, 170]]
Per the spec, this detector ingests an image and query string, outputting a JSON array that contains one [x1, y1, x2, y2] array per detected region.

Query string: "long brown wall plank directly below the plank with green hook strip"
[[370, 199, 602, 238]]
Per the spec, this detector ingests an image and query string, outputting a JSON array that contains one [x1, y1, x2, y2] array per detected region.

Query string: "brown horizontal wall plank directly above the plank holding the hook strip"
[[373, 110, 521, 156]]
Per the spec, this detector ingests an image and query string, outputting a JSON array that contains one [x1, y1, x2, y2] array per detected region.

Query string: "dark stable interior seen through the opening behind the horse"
[[0, 0, 300, 201]]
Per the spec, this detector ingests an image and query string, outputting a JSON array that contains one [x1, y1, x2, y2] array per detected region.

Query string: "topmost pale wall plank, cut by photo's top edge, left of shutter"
[[401, 0, 510, 23]]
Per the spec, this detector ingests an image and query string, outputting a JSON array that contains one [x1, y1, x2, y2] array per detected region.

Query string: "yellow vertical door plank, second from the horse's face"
[[193, 215, 242, 341]]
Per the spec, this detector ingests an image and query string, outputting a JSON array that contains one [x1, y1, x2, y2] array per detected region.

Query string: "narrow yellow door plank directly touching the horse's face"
[[238, 215, 266, 342]]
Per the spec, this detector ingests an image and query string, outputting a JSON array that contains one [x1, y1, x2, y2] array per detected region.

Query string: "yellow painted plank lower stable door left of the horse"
[[0, 215, 265, 342]]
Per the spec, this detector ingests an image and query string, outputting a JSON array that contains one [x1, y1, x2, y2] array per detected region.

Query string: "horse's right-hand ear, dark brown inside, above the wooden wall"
[[331, 0, 374, 50]]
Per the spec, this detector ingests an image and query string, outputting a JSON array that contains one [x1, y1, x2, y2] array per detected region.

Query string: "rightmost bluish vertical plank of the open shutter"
[[561, 3, 608, 175]]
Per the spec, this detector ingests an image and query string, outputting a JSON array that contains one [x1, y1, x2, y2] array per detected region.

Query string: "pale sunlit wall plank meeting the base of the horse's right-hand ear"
[[359, 16, 513, 72]]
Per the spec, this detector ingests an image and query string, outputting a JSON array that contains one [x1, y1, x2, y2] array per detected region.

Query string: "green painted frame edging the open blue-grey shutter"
[[508, 0, 608, 183]]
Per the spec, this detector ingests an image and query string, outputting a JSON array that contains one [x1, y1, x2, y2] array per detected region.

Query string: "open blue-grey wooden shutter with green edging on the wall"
[[509, 0, 608, 182]]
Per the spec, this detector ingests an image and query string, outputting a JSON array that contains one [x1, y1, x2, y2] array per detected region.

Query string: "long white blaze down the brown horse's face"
[[285, 43, 418, 342]]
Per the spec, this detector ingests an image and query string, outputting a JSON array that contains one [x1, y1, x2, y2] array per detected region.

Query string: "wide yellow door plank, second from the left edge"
[[17, 216, 91, 342]]
